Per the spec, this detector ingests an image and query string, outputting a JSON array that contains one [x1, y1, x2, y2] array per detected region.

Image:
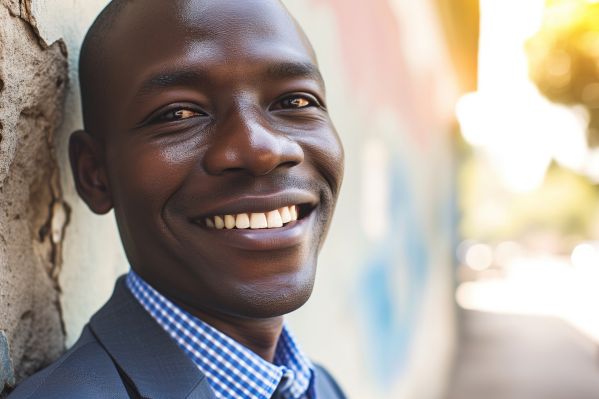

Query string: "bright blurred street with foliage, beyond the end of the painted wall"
[[449, 0, 599, 399]]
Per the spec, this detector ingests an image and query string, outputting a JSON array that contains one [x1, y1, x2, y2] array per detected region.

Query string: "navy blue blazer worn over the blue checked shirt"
[[9, 277, 345, 399]]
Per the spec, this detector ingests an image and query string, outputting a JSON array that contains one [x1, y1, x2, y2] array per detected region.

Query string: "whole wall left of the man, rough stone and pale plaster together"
[[0, 0, 126, 397]]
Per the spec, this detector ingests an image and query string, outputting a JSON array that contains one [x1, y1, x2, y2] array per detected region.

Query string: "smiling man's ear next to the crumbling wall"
[[69, 130, 112, 214]]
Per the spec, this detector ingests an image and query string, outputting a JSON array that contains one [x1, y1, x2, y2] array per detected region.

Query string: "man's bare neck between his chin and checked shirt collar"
[[179, 304, 283, 363]]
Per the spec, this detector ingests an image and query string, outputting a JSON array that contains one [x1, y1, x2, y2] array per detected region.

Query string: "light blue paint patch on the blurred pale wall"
[[359, 161, 432, 387]]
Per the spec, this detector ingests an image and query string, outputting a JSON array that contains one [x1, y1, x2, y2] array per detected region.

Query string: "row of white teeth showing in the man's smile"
[[203, 204, 314, 230]]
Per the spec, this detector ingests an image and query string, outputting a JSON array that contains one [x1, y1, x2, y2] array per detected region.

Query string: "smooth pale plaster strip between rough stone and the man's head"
[[31, 0, 128, 347]]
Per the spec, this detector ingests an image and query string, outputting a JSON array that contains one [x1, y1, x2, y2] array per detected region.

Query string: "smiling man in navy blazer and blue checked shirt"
[[11, 0, 343, 399]]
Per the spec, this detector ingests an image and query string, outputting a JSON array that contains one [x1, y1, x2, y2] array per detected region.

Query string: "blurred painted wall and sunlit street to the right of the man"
[[287, 0, 599, 399]]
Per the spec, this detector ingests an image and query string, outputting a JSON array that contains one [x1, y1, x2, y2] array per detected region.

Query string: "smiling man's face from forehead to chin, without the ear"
[[86, 0, 343, 317]]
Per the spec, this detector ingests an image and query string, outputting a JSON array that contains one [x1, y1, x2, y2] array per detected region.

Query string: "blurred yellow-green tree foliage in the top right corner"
[[526, 0, 599, 147]]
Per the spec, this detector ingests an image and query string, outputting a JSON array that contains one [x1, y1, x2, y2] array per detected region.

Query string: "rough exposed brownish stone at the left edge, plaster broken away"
[[0, 0, 69, 396]]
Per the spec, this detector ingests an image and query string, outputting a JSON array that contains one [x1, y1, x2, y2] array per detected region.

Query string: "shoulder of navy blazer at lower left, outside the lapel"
[[9, 327, 129, 399]]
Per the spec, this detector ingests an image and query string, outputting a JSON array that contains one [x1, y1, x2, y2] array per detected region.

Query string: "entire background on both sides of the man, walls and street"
[[0, 0, 599, 399]]
